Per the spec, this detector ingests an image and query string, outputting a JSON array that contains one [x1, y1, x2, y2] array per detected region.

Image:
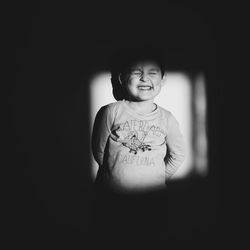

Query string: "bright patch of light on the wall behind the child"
[[90, 72, 207, 180]]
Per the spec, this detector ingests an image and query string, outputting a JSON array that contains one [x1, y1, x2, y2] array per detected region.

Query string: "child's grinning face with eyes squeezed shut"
[[125, 61, 164, 101]]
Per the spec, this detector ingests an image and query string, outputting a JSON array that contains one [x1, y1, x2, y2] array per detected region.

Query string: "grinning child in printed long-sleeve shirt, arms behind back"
[[92, 49, 184, 193]]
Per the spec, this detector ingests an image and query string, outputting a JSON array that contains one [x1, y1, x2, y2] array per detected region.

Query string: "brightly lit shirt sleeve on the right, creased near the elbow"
[[165, 115, 185, 180]]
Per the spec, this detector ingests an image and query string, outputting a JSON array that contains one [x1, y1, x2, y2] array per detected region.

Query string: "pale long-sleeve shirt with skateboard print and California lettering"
[[92, 100, 185, 192]]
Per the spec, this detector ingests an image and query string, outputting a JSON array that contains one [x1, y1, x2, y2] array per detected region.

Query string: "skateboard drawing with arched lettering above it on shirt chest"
[[117, 120, 165, 154]]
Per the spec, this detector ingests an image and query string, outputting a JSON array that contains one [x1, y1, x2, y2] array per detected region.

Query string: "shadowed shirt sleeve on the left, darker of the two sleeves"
[[91, 105, 111, 166]]
